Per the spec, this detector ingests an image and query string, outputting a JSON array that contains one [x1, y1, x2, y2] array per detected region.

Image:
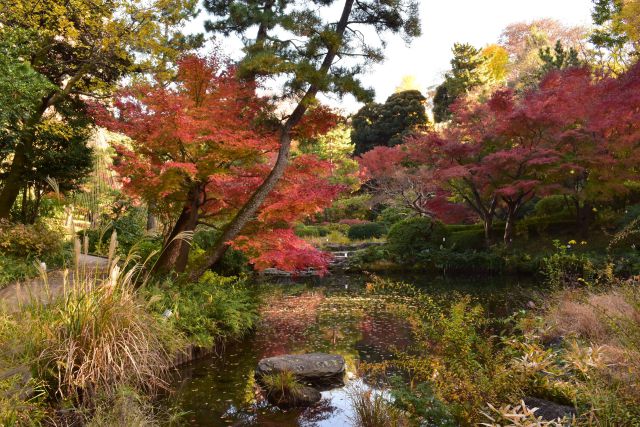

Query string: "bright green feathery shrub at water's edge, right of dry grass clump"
[[149, 271, 258, 347]]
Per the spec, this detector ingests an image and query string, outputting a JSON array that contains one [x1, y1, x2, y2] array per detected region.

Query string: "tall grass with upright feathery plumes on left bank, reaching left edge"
[[0, 235, 185, 424]]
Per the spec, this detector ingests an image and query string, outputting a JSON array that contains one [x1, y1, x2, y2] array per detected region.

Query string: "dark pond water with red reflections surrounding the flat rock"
[[164, 275, 532, 427]]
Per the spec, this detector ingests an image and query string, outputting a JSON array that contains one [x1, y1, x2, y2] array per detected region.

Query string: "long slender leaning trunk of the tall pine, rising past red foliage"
[[189, 0, 355, 281]]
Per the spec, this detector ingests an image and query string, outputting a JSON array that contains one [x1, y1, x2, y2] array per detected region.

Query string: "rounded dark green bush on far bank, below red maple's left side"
[[387, 217, 448, 260]]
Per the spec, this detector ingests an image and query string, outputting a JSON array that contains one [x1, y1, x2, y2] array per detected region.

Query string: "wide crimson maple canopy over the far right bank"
[[360, 64, 640, 243]]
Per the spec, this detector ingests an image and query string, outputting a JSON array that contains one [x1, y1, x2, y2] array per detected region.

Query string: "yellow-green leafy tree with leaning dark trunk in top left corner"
[[0, 0, 202, 218]]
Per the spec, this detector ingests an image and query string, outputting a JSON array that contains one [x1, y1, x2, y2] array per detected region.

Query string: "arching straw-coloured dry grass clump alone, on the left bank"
[[38, 266, 180, 403]]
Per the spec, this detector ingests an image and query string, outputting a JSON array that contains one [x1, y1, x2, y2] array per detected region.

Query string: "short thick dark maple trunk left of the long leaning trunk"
[[153, 186, 200, 273]]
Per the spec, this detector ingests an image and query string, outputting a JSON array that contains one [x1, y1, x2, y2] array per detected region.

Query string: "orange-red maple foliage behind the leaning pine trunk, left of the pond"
[[96, 55, 340, 271]]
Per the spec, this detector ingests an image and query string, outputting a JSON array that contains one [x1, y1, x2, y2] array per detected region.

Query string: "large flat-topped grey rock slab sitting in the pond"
[[256, 353, 345, 387]]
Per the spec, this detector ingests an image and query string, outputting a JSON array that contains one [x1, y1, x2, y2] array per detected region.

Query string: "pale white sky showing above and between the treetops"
[[187, 0, 592, 113]]
